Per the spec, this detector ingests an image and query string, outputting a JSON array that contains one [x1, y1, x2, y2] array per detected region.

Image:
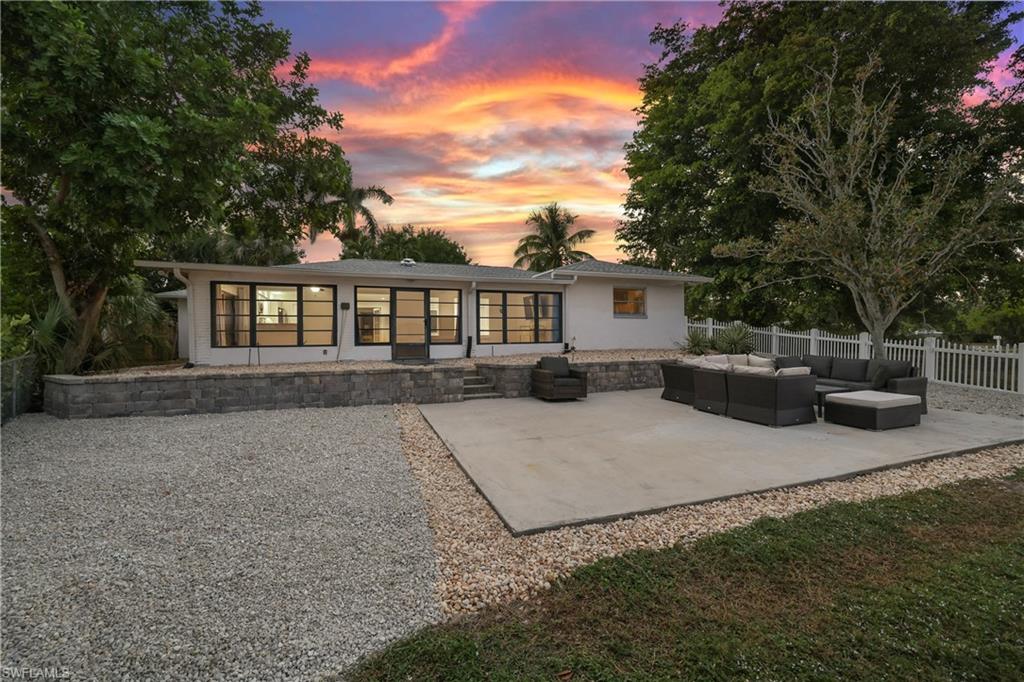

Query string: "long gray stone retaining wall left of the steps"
[[43, 366, 464, 419]]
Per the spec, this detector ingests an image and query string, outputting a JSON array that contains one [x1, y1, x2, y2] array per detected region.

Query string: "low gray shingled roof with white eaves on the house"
[[135, 258, 711, 284]]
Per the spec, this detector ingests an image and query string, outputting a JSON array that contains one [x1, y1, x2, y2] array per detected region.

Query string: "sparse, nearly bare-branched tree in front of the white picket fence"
[[715, 59, 1024, 357]]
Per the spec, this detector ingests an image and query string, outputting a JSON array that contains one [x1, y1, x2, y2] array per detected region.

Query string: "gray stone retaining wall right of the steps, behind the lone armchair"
[[476, 358, 675, 397]]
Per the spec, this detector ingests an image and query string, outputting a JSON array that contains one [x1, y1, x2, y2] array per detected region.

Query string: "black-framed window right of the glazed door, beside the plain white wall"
[[477, 291, 562, 344]]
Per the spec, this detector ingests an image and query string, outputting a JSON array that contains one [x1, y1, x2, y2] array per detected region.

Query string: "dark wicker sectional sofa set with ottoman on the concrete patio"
[[662, 354, 928, 431]]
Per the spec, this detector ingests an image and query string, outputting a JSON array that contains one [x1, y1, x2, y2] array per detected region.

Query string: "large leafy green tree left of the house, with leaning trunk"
[[0, 2, 350, 370]]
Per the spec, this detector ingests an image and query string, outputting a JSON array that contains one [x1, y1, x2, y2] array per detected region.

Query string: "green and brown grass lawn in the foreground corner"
[[353, 472, 1024, 681]]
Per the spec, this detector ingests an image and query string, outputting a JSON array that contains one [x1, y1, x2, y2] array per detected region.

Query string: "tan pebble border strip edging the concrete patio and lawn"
[[395, 404, 1024, 616]]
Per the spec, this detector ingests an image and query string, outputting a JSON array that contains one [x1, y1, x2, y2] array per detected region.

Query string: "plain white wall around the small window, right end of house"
[[565, 278, 684, 350]]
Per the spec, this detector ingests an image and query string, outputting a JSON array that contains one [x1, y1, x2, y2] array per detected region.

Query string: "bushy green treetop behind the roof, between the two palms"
[[341, 225, 470, 265]]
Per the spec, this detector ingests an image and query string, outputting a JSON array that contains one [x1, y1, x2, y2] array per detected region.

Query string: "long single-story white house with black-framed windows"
[[136, 259, 710, 365]]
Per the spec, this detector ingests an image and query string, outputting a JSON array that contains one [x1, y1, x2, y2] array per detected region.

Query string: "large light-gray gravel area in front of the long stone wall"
[[0, 407, 439, 680]]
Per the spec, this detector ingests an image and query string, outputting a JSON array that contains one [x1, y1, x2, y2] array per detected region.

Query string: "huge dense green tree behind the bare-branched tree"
[[616, 2, 1022, 328]]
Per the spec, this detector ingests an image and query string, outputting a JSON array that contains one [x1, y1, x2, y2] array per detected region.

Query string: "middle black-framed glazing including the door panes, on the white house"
[[355, 287, 462, 346]]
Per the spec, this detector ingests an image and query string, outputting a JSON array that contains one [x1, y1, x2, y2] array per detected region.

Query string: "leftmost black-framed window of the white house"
[[212, 282, 337, 348]]
